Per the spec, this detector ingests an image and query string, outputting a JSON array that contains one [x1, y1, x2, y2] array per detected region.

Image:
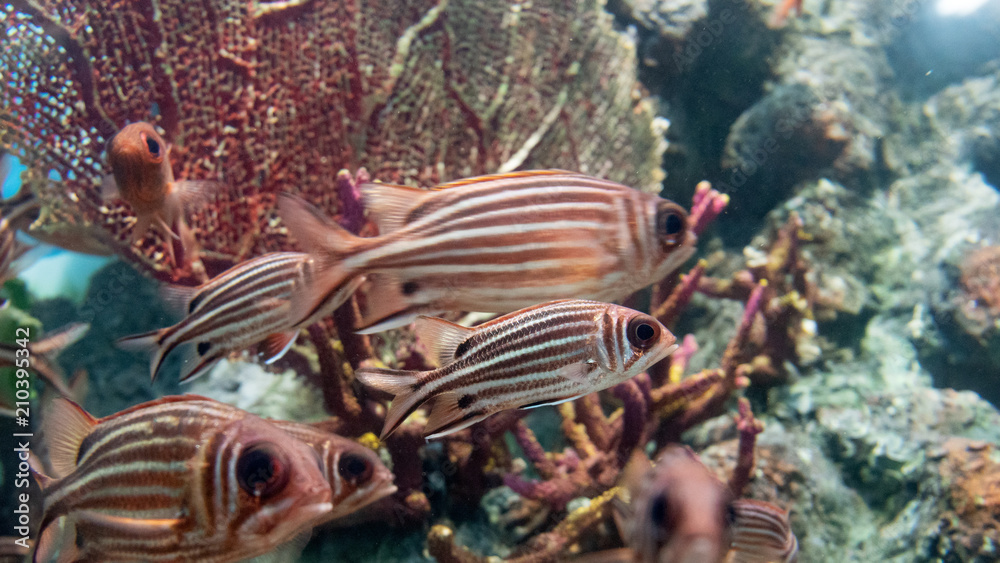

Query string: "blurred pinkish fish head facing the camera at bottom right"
[[627, 446, 732, 563]]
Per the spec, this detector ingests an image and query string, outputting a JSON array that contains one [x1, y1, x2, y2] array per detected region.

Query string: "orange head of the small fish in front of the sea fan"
[[108, 122, 174, 206]]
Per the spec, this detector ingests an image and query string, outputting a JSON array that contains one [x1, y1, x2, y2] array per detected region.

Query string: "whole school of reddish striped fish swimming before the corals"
[[0, 122, 797, 563]]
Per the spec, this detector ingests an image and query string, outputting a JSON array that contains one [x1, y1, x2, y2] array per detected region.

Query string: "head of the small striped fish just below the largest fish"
[[595, 305, 677, 381]]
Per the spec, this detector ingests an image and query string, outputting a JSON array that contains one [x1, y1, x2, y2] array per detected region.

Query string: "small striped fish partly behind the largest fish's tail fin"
[[118, 252, 362, 381]]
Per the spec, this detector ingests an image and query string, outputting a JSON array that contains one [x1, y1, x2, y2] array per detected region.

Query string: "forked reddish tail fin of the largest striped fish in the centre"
[[278, 194, 361, 325]]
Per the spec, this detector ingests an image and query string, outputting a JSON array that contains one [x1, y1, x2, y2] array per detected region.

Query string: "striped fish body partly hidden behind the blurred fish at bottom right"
[[728, 499, 799, 563]]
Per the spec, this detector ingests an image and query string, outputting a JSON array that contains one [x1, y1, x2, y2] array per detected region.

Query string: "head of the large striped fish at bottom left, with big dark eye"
[[225, 424, 333, 551]]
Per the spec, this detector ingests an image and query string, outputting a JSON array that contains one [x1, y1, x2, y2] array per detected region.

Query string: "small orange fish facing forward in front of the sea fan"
[[104, 122, 221, 264]]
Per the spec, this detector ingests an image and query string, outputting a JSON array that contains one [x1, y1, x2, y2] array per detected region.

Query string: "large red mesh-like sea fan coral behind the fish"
[[0, 0, 663, 283]]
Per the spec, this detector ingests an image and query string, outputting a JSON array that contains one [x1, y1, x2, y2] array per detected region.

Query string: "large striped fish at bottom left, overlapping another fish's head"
[[35, 395, 333, 563]]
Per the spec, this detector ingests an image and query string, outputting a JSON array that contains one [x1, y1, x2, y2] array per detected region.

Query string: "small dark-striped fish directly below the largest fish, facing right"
[[357, 300, 677, 439]]
